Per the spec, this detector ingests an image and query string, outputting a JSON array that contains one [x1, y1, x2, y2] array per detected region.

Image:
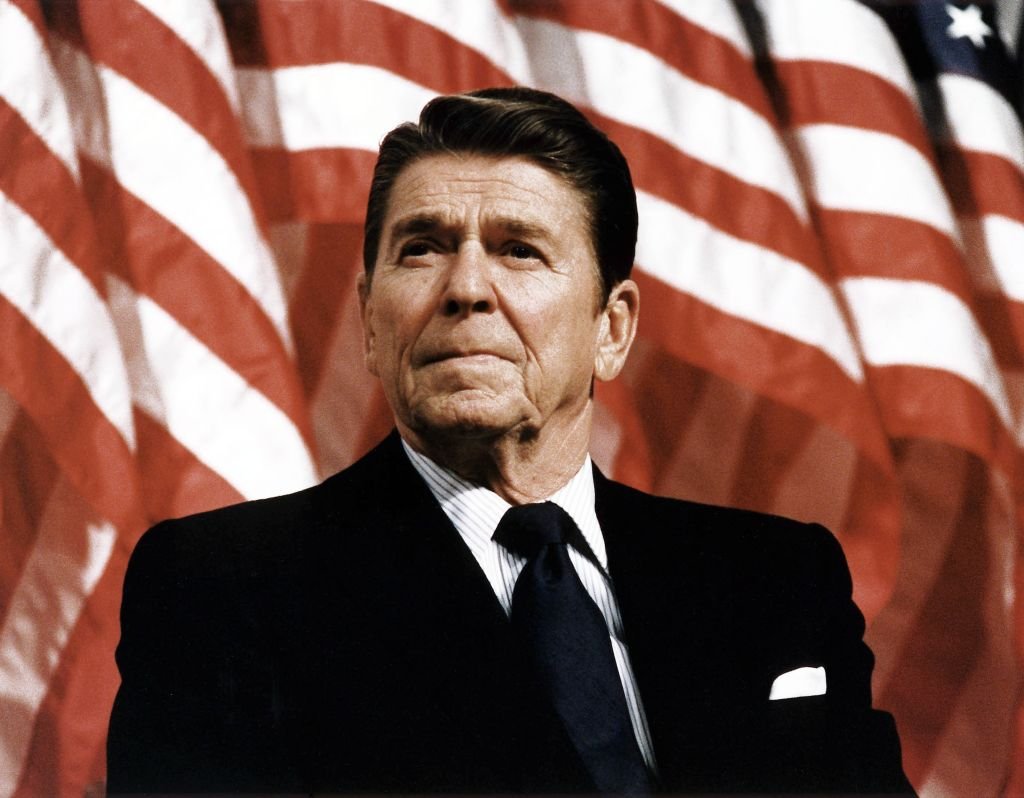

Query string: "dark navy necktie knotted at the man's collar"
[[494, 502, 650, 793]]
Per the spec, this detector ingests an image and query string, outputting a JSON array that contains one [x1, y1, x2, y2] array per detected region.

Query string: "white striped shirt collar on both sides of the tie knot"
[[401, 439, 608, 570]]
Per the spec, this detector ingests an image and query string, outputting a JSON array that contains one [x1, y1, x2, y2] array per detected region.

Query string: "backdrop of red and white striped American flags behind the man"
[[0, 0, 1024, 796]]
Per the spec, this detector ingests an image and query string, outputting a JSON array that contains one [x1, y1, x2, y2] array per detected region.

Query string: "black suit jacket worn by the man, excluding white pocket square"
[[109, 433, 910, 793]]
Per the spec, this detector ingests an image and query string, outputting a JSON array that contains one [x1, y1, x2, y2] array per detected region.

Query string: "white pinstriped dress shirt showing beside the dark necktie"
[[401, 440, 655, 772]]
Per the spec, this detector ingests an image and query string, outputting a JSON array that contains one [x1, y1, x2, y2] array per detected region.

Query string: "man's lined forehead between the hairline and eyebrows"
[[384, 155, 589, 234]]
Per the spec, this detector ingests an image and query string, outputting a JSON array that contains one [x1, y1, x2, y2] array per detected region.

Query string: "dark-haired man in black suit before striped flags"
[[110, 89, 911, 793]]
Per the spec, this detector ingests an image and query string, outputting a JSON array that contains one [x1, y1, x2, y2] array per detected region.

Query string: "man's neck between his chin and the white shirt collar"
[[398, 407, 592, 504]]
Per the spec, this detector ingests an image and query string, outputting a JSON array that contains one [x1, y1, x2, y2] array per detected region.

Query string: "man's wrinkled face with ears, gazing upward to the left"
[[359, 155, 635, 446]]
